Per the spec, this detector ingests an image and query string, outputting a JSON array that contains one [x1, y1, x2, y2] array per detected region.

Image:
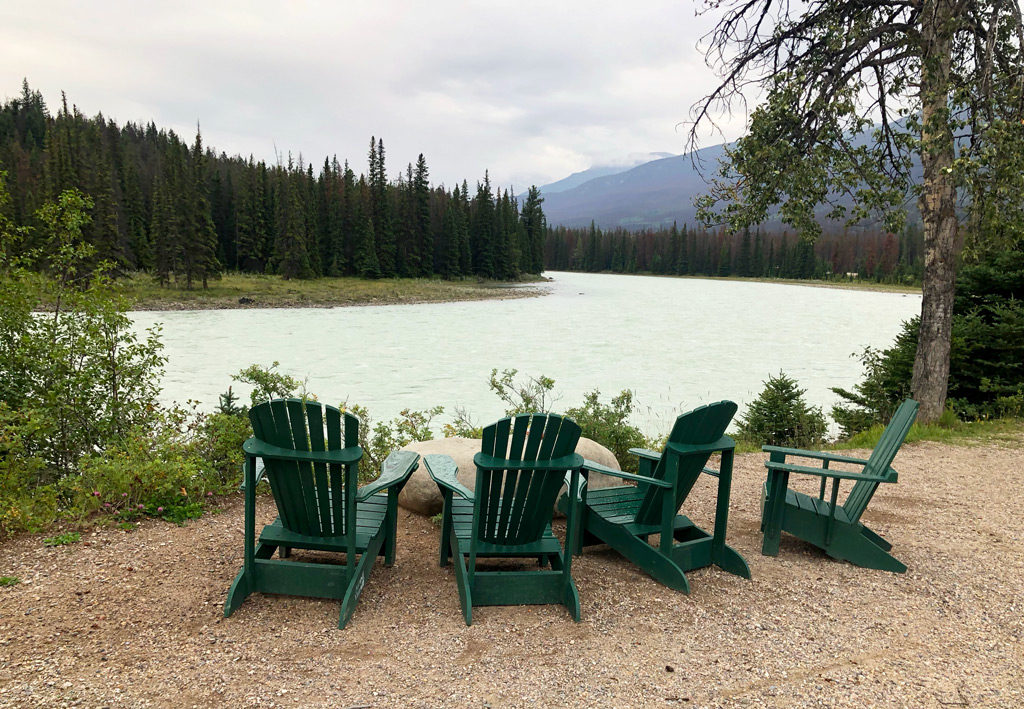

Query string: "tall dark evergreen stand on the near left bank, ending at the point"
[[0, 81, 546, 288]]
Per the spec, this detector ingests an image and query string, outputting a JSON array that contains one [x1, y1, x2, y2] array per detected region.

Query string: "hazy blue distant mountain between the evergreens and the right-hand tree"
[[541, 145, 725, 230]]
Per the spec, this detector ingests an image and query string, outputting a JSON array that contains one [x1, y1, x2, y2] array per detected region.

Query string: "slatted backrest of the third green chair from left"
[[636, 402, 737, 525]]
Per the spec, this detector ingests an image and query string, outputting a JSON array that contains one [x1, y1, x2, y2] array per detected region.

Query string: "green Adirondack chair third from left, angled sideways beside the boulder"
[[560, 402, 751, 593]]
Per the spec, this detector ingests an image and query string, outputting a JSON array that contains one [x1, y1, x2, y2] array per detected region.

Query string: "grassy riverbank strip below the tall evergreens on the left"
[[118, 274, 546, 310]]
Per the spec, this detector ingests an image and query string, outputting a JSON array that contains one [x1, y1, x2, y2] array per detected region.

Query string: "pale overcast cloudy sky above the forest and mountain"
[[0, 0, 740, 191]]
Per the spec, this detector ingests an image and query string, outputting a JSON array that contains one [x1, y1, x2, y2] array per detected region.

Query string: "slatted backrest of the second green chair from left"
[[476, 414, 581, 545]]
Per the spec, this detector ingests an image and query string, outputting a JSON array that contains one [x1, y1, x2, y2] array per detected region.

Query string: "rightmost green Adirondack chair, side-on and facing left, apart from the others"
[[761, 399, 918, 574]]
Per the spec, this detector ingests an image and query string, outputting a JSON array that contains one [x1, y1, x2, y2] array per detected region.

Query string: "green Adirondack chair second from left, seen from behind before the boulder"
[[423, 414, 583, 625]]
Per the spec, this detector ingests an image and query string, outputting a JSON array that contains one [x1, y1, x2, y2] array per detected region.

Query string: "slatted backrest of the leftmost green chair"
[[249, 399, 359, 537]]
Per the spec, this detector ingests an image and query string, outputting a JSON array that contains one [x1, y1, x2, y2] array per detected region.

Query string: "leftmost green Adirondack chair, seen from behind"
[[224, 399, 419, 628]]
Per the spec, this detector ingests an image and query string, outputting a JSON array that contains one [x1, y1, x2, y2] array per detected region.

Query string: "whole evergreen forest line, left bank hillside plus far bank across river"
[[0, 81, 923, 289]]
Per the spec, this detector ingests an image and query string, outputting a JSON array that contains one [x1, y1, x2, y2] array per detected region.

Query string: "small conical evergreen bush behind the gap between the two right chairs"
[[738, 372, 825, 448]]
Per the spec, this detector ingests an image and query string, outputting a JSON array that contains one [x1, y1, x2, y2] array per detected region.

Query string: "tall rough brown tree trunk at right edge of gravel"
[[910, 0, 958, 422]]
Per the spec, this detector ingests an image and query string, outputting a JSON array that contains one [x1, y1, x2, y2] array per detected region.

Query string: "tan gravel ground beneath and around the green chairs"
[[0, 435, 1024, 707]]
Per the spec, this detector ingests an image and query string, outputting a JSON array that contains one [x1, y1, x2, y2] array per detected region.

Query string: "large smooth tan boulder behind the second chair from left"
[[398, 437, 622, 515]]
